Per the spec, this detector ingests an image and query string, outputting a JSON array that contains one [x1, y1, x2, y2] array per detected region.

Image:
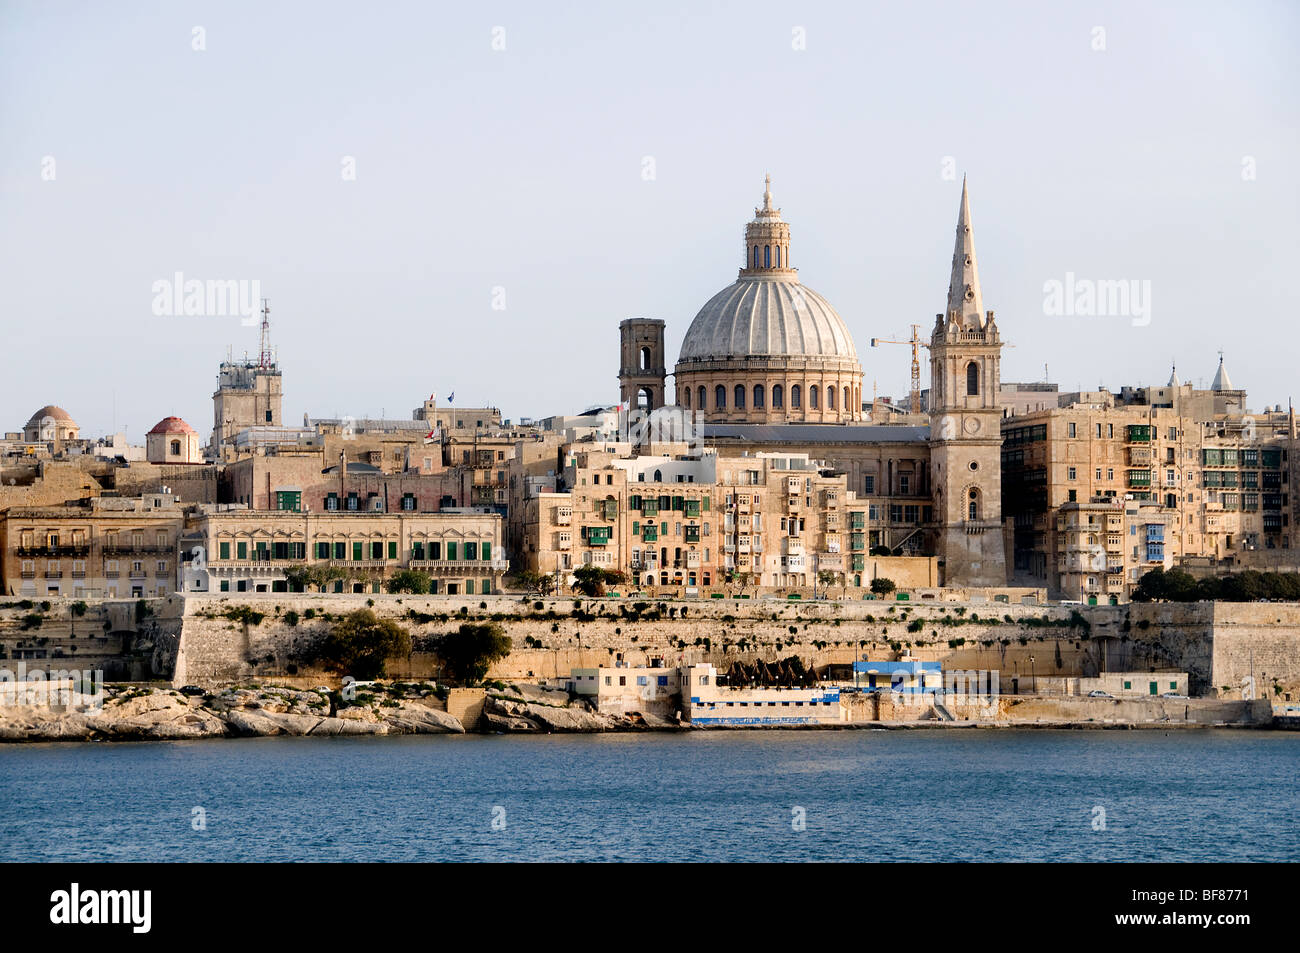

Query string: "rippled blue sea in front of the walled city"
[[0, 729, 1300, 862]]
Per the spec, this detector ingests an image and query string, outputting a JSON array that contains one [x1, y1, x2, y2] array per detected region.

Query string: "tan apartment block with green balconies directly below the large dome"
[[525, 451, 865, 590]]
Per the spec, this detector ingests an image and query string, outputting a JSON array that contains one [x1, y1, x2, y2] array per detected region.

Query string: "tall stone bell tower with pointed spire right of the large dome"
[[928, 178, 1008, 586]]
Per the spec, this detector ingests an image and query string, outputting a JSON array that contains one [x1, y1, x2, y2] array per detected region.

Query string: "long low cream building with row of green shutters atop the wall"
[[183, 504, 507, 595]]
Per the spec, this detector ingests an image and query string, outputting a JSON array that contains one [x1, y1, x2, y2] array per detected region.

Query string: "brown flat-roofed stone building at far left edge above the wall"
[[0, 493, 185, 599]]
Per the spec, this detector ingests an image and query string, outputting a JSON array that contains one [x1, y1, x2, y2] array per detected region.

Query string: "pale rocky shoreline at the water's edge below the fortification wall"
[[0, 683, 688, 742]]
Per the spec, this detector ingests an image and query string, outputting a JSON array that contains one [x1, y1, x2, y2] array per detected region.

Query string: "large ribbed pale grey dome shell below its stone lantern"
[[679, 277, 858, 361]]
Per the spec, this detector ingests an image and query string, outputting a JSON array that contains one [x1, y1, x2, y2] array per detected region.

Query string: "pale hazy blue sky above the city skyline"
[[0, 0, 1300, 442]]
